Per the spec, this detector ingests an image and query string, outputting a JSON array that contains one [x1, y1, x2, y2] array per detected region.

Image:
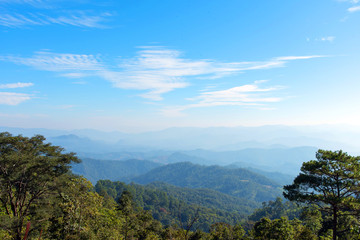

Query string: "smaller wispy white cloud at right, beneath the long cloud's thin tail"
[[161, 81, 284, 117]]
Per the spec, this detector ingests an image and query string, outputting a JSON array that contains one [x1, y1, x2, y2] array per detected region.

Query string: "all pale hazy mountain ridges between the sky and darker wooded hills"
[[0, 125, 360, 176]]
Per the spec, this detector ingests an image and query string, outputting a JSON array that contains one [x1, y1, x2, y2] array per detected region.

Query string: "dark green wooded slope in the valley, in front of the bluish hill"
[[95, 180, 245, 231]]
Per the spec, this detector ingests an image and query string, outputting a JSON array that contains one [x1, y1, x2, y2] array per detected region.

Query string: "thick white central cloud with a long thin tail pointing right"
[[100, 47, 321, 100]]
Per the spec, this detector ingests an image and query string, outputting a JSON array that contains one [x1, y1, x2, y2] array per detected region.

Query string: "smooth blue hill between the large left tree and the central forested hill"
[[72, 158, 161, 184]]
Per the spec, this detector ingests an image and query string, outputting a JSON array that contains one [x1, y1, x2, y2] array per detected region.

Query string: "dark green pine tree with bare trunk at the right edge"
[[284, 150, 360, 240]]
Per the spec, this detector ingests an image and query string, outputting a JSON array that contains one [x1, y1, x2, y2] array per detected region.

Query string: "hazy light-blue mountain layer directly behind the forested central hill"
[[74, 147, 317, 177]]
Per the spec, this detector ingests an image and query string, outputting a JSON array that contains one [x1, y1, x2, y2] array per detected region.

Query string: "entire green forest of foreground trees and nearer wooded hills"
[[0, 132, 360, 240]]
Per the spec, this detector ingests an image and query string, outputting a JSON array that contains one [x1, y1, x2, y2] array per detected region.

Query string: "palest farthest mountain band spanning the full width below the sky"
[[0, 125, 360, 154]]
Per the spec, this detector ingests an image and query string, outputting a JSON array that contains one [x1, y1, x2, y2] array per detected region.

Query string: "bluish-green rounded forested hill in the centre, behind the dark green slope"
[[132, 162, 281, 202]]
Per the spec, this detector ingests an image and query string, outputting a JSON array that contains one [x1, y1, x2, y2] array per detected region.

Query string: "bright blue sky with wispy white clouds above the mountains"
[[0, 0, 360, 132]]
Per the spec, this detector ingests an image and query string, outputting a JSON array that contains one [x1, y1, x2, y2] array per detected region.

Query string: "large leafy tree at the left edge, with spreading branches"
[[0, 132, 80, 240]]
